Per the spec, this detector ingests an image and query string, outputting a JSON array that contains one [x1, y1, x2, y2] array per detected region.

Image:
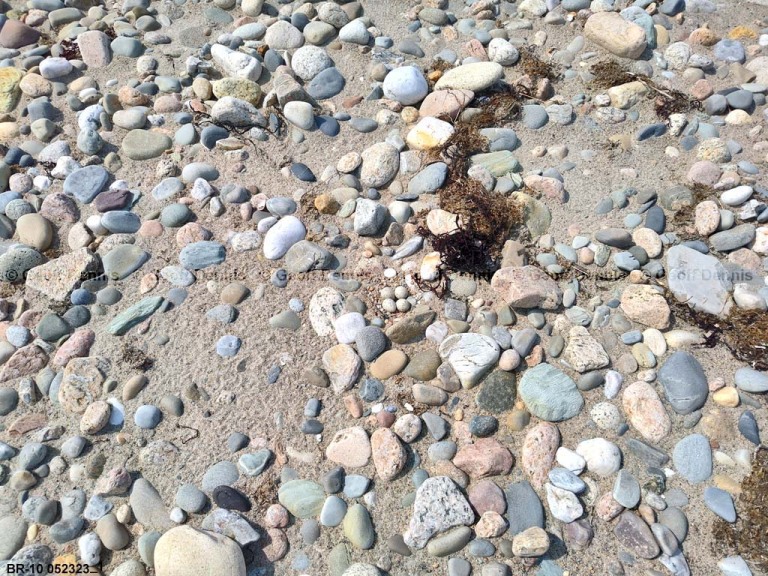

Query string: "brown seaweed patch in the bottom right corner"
[[713, 448, 768, 574]]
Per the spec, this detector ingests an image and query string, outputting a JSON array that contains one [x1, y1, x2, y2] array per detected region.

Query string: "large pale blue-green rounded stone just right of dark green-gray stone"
[[518, 363, 584, 422]]
